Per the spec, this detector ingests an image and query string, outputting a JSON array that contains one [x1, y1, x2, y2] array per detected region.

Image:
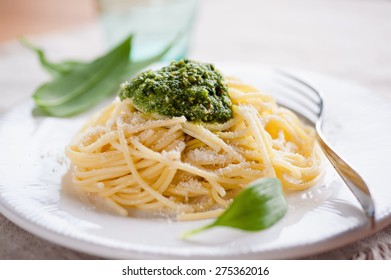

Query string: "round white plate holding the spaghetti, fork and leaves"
[[0, 65, 391, 259]]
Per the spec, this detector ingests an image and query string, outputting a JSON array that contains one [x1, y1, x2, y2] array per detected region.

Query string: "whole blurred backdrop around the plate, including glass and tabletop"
[[0, 0, 391, 259]]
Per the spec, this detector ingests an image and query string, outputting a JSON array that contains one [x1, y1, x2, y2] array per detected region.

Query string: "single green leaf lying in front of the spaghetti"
[[182, 178, 288, 238]]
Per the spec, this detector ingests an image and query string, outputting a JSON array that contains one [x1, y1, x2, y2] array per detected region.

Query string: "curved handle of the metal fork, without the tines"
[[316, 127, 375, 228]]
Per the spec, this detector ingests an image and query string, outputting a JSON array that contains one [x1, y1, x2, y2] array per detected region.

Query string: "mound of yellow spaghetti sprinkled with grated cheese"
[[66, 78, 322, 220]]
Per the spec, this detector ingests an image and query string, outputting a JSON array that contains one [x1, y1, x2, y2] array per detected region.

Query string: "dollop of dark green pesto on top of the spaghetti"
[[119, 59, 232, 123]]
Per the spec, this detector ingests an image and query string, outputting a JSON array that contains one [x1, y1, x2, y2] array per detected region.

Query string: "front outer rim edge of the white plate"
[[0, 195, 391, 259]]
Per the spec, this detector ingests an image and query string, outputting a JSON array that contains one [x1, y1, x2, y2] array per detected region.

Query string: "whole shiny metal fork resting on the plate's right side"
[[276, 69, 375, 229]]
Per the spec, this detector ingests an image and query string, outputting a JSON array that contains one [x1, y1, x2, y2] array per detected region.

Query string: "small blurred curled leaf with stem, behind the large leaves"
[[19, 38, 85, 77]]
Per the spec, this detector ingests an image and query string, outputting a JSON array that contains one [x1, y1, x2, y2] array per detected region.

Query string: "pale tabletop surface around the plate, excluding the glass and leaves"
[[0, 0, 391, 259]]
